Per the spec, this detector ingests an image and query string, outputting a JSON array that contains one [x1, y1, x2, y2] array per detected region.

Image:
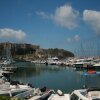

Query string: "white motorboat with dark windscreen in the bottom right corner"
[[70, 88, 100, 100]]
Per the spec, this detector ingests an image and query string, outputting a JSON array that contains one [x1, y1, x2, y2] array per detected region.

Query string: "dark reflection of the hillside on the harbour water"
[[10, 63, 62, 78]]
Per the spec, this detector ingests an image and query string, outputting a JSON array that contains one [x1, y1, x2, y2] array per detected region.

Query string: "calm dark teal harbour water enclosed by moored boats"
[[11, 62, 100, 92]]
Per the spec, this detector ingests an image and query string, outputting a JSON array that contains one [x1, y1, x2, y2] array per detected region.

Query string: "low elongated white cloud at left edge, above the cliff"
[[0, 28, 26, 40]]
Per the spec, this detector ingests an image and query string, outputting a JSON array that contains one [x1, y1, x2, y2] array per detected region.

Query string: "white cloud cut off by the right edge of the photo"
[[83, 10, 100, 35]]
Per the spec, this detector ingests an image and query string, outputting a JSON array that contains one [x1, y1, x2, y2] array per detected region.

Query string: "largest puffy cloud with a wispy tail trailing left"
[[36, 5, 79, 29]]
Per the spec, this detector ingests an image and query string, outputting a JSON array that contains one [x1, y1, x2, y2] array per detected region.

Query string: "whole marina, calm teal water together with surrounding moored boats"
[[0, 52, 100, 100]]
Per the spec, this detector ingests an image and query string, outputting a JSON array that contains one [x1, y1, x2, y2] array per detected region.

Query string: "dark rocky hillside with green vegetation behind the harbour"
[[0, 42, 74, 60]]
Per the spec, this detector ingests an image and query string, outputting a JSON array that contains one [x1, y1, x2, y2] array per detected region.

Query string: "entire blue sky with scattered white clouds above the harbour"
[[0, 0, 100, 56]]
